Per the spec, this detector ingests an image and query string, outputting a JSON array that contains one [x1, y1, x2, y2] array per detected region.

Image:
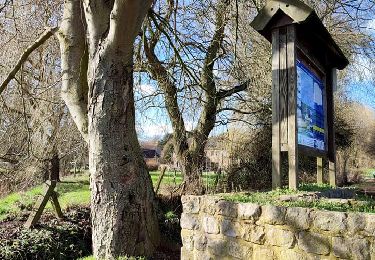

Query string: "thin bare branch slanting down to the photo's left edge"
[[0, 27, 58, 94]]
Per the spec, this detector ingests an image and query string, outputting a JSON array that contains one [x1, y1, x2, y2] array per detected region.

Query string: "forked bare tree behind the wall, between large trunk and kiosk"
[[143, 0, 247, 194]]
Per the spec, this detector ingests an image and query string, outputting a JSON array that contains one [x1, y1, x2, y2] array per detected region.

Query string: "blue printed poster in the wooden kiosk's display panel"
[[297, 60, 325, 151]]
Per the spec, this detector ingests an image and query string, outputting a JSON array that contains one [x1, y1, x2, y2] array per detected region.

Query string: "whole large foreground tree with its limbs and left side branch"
[[1, 0, 159, 259]]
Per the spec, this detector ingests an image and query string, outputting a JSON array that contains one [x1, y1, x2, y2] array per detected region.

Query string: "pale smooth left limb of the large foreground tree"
[[56, 0, 88, 142]]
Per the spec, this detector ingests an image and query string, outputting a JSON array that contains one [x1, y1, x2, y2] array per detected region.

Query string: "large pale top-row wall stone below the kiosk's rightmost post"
[[313, 210, 347, 234]]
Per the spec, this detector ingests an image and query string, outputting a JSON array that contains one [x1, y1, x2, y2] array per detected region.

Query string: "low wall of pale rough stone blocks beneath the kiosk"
[[181, 196, 375, 260]]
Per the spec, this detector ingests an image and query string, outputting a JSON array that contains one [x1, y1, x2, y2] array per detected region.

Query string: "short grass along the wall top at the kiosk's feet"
[[223, 184, 375, 213]]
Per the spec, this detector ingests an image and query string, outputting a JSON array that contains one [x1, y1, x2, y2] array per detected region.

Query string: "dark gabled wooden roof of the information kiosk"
[[251, 0, 349, 69]]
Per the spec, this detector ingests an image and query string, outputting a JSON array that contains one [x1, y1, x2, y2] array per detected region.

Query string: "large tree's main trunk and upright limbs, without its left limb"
[[85, 0, 159, 259]]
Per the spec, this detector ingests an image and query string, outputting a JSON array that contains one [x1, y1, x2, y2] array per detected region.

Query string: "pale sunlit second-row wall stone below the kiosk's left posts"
[[266, 226, 295, 248]]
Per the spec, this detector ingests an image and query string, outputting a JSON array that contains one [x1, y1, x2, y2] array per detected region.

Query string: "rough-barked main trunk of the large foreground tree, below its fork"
[[89, 55, 159, 259]]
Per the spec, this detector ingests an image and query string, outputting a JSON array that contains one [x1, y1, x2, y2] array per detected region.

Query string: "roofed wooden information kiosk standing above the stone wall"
[[251, 0, 349, 189]]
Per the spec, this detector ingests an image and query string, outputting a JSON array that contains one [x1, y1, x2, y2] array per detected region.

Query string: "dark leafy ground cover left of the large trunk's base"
[[0, 208, 91, 260]]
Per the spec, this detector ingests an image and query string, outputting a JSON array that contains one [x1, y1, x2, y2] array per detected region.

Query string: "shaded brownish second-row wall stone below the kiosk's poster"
[[298, 231, 330, 255]]
